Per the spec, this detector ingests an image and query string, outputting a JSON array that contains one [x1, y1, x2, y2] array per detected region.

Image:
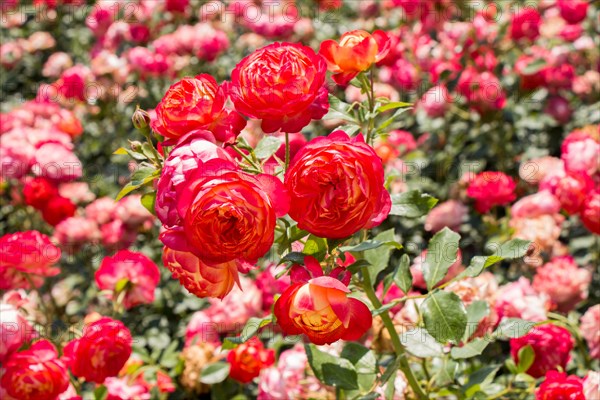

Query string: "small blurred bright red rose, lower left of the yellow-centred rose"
[[227, 337, 275, 383]]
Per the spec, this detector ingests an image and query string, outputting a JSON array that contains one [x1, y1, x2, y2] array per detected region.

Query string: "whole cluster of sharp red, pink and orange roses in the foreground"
[[152, 31, 391, 344]]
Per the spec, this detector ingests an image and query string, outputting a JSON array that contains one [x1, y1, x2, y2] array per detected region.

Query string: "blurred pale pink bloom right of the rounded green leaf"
[[494, 277, 551, 322]]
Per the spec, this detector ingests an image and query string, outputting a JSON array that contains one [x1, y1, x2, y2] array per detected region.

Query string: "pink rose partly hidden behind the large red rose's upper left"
[[155, 130, 232, 227]]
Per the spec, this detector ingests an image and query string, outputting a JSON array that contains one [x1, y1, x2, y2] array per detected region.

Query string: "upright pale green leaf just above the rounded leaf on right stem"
[[423, 227, 460, 290]]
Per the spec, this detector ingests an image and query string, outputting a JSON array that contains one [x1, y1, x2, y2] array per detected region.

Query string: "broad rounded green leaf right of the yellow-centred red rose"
[[421, 291, 467, 344]]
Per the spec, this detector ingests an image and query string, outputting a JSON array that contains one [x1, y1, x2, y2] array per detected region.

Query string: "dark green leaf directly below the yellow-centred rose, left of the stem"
[[304, 344, 358, 390]]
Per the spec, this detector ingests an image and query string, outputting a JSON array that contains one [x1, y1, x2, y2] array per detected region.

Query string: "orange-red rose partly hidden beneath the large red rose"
[[163, 247, 238, 299]]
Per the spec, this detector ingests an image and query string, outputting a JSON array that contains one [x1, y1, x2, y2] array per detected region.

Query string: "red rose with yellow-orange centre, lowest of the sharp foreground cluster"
[[274, 264, 372, 345]]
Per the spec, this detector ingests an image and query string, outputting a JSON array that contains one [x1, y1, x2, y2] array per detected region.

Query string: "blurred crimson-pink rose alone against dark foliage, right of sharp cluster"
[[467, 171, 517, 214]]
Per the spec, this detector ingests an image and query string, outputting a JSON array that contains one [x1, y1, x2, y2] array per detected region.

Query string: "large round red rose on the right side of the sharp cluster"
[[285, 131, 391, 239]]
